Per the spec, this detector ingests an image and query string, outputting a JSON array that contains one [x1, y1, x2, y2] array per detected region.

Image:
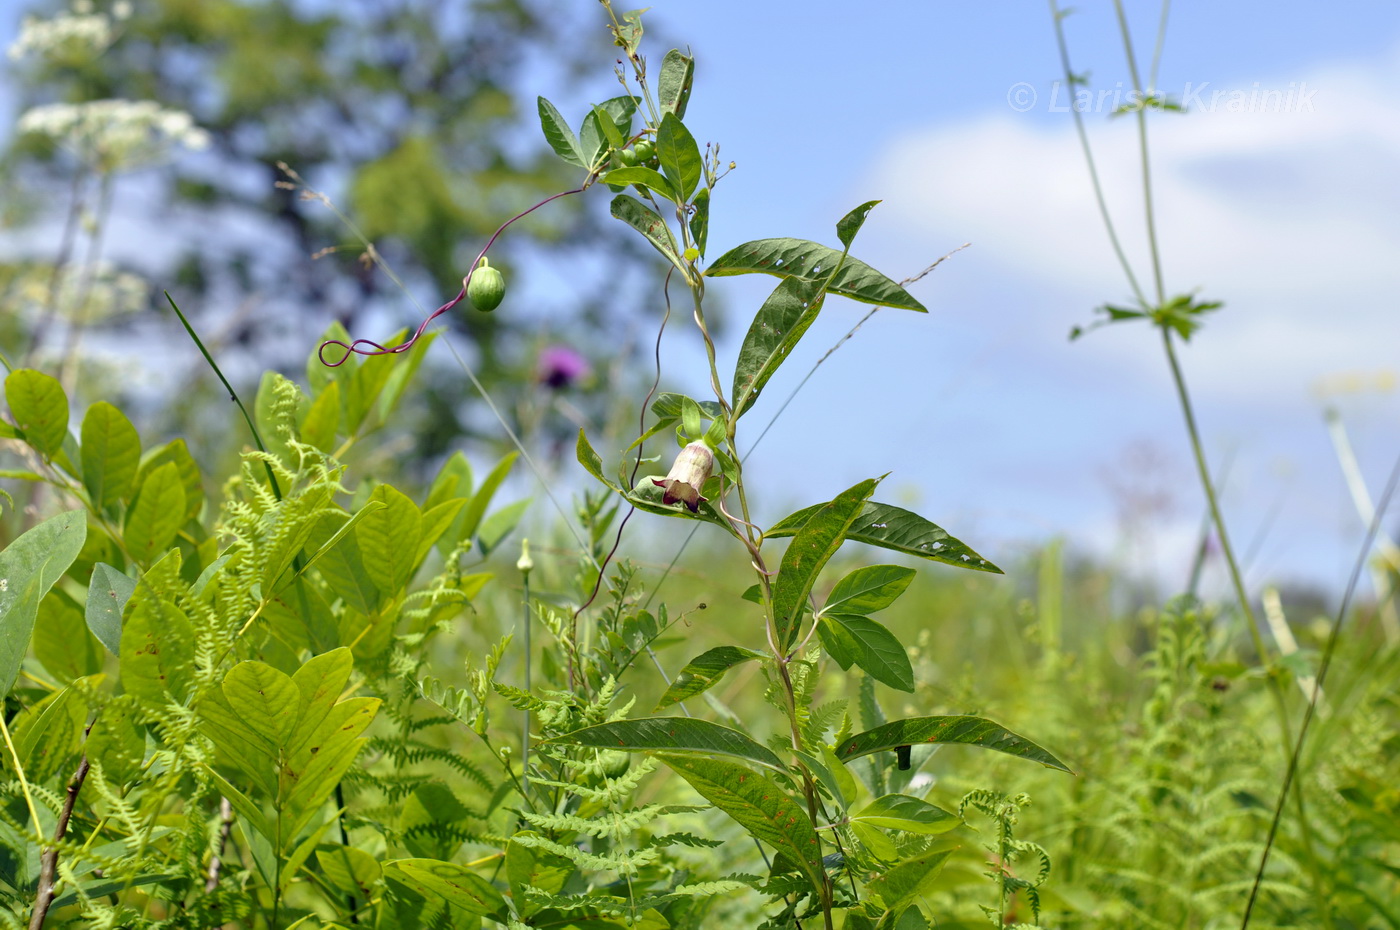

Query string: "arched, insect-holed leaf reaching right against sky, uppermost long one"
[[706, 238, 928, 312]]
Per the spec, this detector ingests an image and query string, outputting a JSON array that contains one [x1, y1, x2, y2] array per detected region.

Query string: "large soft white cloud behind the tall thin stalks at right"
[[862, 49, 1400, 408]]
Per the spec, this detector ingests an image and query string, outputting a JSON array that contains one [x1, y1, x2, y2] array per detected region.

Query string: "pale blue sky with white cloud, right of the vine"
[[0, 0, 1400, 588]]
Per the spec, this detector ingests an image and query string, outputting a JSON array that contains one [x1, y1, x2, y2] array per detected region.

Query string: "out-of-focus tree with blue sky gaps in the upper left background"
[[0, 0, 666, 473]]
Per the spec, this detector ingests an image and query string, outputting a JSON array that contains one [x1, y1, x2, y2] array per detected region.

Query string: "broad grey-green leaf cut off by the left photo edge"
[[0, 509, 87, 696]]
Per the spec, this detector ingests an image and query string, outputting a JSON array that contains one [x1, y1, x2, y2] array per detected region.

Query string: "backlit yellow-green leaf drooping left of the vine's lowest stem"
[[661, 755, 823, 889]]
